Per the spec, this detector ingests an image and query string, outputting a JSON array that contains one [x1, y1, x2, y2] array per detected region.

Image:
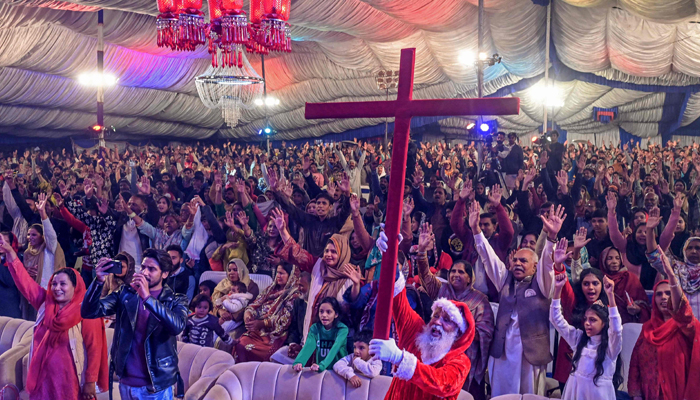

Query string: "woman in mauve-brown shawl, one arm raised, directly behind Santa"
[[416, 223, 494, 400]]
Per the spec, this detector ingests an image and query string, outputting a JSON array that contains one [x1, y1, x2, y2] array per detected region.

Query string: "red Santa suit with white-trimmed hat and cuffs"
[[385, 276, 475, 400]]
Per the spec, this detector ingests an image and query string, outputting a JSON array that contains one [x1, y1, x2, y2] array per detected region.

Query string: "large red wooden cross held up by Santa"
[[305, 49, 520, 339]]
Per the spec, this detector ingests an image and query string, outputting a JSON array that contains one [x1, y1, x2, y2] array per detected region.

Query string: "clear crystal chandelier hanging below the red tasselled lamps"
[[195, 54, 264, 128]]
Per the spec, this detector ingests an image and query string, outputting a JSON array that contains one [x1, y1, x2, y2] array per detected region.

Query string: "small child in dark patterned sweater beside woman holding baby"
[[182, 294, 232, 347]]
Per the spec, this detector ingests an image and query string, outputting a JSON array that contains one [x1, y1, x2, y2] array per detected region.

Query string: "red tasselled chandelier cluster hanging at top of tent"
[[156, 0, 292, 68]]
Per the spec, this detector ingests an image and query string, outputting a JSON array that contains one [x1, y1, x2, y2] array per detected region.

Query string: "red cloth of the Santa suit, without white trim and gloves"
[[385, 289, 475, 400]]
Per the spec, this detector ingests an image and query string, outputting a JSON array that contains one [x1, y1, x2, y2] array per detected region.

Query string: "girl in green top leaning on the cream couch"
[[293, 297, 348, 372]]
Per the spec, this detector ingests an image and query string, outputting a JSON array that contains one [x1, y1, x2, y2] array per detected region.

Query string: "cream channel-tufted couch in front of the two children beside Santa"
[[204, 362, 473, 400]]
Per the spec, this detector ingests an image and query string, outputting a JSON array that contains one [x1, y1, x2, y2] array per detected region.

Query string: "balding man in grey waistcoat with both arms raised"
[[469, 202, 566, 397]]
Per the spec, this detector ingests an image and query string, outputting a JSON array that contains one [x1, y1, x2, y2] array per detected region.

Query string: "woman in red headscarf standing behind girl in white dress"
[[599, 247, 651, 324]]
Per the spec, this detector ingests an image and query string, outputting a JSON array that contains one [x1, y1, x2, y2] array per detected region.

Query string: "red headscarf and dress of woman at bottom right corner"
[[642, 280, 700, 400]]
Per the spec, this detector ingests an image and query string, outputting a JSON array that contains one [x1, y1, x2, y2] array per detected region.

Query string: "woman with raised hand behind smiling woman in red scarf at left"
[[22, 193, 66, 320]]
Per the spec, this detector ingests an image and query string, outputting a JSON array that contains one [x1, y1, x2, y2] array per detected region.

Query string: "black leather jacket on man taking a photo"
[[80, 280, 188, 392]]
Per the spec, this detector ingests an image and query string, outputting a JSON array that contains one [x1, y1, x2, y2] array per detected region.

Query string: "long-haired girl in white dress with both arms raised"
[[550, 257, 622, 400]]
